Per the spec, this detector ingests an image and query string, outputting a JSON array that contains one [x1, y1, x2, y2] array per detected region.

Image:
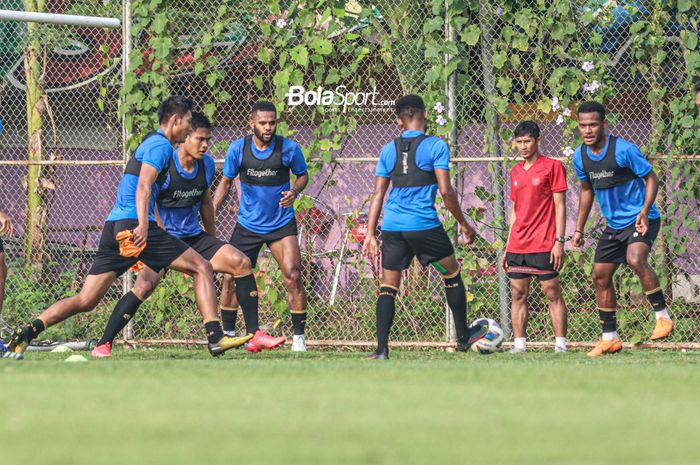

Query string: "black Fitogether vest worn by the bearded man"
[[239, 136, 289, 186]]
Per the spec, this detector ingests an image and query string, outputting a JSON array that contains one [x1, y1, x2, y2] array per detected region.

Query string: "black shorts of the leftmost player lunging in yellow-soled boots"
[[88, 220, 189, 276]]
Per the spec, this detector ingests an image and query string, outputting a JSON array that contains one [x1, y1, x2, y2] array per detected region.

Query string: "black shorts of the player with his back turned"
[[382, 225, 455, 271]]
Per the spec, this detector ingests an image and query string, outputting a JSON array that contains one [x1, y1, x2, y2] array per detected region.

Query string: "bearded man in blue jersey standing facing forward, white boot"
[[214, 101, 309, 352]]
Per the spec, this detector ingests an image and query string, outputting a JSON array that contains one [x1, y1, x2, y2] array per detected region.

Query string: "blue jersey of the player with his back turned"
[[374, 131, 450, 231]]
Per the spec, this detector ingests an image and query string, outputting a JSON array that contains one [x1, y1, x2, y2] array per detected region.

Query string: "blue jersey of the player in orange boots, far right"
[[573, 135, 661, 229]]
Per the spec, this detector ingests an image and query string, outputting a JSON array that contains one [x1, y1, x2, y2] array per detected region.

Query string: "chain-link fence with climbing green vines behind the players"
[[0, 0, 700, 345]]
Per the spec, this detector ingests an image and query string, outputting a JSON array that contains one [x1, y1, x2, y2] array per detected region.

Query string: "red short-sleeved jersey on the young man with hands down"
[[506, 155, 568, 253]]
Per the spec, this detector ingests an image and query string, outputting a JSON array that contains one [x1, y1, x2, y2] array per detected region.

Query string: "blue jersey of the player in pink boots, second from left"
[[158, 150, 216, 237]]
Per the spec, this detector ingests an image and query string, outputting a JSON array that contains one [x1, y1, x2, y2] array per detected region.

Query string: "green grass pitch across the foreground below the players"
[[0, 349, 700, 465]]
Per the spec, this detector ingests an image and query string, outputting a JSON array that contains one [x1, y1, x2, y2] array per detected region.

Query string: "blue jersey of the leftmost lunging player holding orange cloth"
[[107, 129, 173, 221]]
